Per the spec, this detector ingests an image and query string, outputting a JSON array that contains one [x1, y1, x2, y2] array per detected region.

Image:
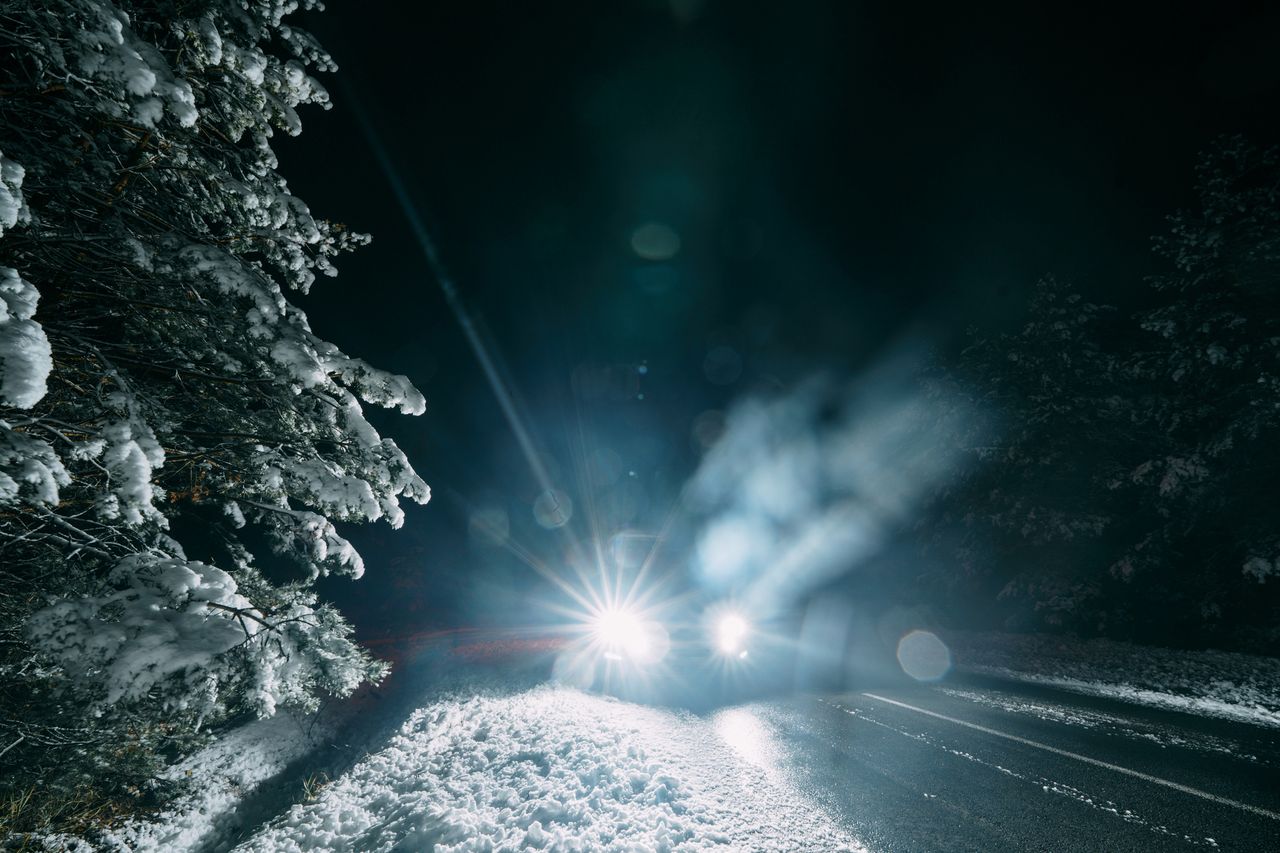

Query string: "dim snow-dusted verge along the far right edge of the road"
[[945, 631, 1280, 727]]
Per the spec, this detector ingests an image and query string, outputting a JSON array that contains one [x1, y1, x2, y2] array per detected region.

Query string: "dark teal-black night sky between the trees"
[[278, 0, 1280, 635]]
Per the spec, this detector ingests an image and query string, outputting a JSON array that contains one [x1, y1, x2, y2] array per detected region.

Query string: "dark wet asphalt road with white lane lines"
[[739, 679, 1280, 852]]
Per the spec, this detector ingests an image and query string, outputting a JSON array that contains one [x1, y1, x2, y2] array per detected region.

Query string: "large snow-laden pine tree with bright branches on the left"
[[0, 0, 429, 824]]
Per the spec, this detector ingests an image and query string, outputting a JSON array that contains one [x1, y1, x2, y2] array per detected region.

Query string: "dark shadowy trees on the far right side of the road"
[[914, 138, 1280, 652]]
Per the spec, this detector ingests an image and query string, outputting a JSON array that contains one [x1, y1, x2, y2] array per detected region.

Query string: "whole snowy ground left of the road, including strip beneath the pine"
[[45, 643, 865, 853]]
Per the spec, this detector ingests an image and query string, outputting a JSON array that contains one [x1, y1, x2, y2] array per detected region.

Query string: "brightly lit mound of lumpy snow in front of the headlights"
[[237, 685, 865, 853]]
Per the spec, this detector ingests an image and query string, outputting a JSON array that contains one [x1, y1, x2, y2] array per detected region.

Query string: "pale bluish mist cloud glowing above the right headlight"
[[686, 346, 975, 613]]
